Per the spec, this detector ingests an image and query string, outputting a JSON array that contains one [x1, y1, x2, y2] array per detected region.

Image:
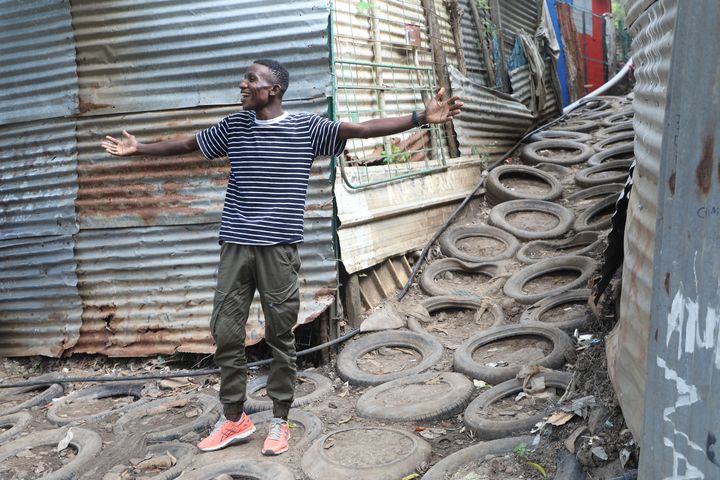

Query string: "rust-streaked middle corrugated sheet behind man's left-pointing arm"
[[77, 98, 327, 228]]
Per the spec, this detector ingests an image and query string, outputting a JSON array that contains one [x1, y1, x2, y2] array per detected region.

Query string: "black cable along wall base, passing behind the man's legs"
[[0, 328, 360, 389]]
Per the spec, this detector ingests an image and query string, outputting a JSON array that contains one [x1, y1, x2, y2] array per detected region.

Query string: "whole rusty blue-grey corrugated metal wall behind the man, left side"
[[0, 0, 337, 356]]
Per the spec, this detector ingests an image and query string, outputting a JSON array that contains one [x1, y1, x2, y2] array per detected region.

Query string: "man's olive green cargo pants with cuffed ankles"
[[210, 243, 300, 417]]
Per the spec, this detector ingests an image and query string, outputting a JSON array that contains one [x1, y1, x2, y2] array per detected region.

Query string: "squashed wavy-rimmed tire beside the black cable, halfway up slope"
[[420, 258, 507, 297]]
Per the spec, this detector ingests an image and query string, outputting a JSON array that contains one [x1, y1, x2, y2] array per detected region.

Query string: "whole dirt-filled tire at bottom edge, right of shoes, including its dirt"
[[301, 427, 431, 480]]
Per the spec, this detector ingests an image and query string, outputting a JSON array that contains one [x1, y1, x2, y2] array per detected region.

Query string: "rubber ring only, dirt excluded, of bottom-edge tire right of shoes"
[[301, 427, 431, 480]]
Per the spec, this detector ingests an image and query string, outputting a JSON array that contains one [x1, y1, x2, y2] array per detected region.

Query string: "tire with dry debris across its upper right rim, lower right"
[[463, 372, 572, 440]]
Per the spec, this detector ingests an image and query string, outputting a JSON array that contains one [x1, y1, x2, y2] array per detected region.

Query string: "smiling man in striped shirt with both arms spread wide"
[[101, 59, 462, 455]]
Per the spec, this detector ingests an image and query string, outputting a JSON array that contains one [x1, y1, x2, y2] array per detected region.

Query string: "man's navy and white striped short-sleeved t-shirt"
[[197, 111, 345, 245]]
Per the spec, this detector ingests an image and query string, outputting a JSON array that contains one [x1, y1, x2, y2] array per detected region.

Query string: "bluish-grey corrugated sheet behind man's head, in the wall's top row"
[[72, 0, 330, 114]]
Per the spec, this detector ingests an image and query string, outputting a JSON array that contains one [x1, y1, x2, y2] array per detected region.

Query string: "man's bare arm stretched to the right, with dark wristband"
[[339, 88, 463, 141]]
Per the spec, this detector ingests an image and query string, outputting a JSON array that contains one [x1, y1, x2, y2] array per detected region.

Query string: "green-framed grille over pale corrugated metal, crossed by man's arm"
[[333, 0, 449, 188]]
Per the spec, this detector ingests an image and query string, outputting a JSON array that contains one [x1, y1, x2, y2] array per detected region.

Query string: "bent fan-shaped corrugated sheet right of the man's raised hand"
[[450, 68, 533, 161]]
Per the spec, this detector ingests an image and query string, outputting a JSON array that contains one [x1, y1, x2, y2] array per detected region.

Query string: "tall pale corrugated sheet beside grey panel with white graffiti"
[[607, 0, 676, 440]]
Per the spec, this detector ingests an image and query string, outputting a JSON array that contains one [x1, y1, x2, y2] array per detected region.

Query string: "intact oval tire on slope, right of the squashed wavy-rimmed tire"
[[503, 255, 598, 305]]
